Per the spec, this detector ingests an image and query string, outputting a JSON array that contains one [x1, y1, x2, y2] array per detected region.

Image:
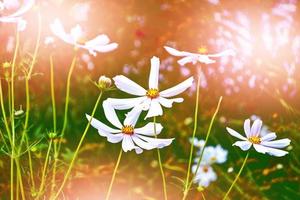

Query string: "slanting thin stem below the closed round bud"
[[53, 91, 102, 200]]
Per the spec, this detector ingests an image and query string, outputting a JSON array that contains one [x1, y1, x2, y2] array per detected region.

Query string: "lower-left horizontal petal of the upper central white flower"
[[105, 96, 147, 110]]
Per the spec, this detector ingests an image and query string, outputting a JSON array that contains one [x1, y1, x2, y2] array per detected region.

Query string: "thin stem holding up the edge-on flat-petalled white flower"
[[185, 72, 200, 191]]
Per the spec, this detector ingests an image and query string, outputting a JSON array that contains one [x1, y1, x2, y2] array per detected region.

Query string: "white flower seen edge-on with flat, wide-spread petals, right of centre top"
[[164, 46, 235, 65]]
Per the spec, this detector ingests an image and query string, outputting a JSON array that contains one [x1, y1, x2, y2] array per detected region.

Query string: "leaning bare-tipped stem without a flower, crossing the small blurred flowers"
[[182, 97, 223, 200]]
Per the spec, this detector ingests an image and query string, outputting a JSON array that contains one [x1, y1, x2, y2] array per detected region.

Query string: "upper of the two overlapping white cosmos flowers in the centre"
[[106, 57, 194, 119]]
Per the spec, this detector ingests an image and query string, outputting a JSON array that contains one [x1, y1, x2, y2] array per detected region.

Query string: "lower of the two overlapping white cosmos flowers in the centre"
[[86, 102, 173, 154]]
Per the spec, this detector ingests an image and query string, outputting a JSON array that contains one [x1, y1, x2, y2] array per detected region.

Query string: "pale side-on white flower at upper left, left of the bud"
[[50, 19, 118, 56]]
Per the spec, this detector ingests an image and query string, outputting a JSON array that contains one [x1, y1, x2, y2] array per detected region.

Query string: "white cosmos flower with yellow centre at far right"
[[226, 119, 291, 157]]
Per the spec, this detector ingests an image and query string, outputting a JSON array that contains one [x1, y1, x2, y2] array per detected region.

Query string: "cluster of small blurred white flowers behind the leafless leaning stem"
[[190, 138, 228, 187]]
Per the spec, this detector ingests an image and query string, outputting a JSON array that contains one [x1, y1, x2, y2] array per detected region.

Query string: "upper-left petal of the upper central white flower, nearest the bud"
[[113, 75, 147, 96]]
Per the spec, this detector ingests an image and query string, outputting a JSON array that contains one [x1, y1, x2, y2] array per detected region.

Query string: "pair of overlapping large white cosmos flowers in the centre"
[[87, 57, 193, 154]]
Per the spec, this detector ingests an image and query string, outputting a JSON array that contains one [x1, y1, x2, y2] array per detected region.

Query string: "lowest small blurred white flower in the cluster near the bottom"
[[192, 165, 217, 187]]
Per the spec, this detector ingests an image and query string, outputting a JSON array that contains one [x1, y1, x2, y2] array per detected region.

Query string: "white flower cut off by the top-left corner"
[[0, 0, 35, 31]]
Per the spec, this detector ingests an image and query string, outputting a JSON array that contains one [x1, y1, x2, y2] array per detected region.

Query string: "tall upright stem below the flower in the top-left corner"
[[10, 28, 20, 200]]
